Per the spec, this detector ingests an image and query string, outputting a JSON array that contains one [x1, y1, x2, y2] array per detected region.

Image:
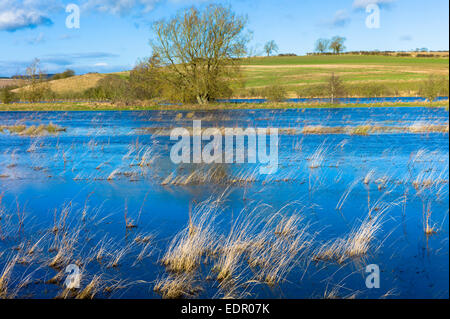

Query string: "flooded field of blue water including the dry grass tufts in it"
[[0, 107, 449, 298]]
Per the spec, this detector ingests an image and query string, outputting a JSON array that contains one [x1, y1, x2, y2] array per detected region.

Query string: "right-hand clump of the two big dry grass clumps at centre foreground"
[[214, 205, 313, 286]]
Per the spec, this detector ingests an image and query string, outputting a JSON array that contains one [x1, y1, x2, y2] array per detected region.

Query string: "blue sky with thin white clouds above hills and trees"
[[0, 0, 449, 76]]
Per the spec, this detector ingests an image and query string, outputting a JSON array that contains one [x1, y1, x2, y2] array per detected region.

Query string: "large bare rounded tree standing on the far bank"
[[151, 5, 249, 104]]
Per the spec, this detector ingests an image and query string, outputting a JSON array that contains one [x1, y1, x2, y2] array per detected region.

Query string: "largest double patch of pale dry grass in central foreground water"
[[155, 201, 314, 298]]
